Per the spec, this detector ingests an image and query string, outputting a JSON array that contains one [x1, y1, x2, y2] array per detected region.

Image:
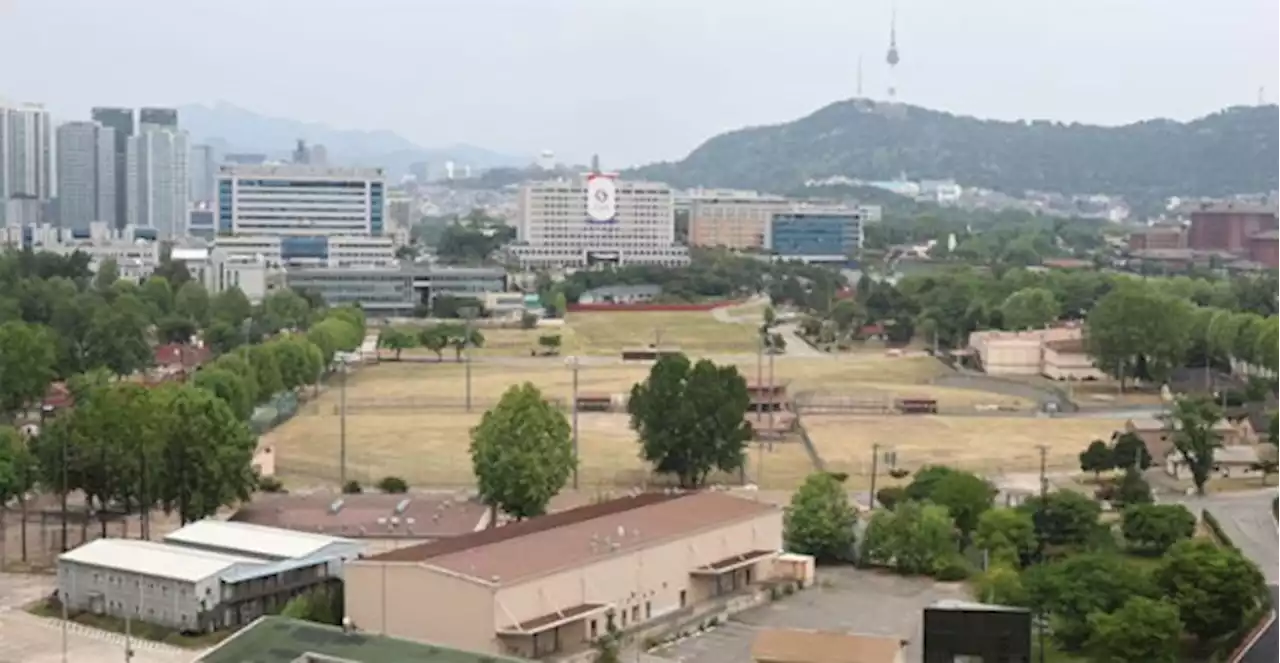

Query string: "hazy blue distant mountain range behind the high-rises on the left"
[[178, 102, 532, 175]]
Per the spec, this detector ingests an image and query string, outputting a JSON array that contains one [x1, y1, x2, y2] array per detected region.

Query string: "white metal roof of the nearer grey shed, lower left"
[[58, 539, 262, 582]]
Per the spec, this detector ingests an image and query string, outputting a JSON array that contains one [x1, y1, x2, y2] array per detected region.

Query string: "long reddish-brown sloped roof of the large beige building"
[[369, 491, 778, 584]]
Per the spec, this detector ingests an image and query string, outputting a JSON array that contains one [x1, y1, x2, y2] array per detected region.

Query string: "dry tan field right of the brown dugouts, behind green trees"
[[804, 415, 1124, 477]]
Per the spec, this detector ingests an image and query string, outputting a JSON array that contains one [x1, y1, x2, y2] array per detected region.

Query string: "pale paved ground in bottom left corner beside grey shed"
[[0, 573, 196, 663]]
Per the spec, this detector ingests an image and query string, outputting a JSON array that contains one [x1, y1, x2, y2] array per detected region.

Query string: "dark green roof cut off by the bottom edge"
[[196, 617, 527, 663]]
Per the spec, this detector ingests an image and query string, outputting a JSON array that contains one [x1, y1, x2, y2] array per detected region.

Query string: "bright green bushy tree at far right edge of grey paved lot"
[[860, 502, 956, 575]]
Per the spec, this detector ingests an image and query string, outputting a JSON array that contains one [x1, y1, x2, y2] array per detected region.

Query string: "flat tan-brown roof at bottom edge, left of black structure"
[[751, 628, 902, 663]]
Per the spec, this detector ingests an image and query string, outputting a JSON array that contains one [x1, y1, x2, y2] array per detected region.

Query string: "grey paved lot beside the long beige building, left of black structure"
[[649, 568, 969, 663]]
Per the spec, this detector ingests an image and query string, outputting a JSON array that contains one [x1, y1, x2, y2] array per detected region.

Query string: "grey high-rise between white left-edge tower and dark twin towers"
[[58, 122, 118, 230]]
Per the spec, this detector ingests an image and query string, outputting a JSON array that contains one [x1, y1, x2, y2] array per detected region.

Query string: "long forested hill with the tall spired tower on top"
[[632, 100, 1280, 202]]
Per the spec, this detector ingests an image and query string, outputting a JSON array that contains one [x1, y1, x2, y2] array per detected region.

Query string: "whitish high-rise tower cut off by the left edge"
[[0, 102, 58, 201]]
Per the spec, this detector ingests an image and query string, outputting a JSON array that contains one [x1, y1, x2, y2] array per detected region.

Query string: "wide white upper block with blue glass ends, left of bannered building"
[[216, 164, 387, 238]]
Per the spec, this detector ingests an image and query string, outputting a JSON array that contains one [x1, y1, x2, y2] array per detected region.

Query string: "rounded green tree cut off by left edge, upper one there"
[[0, 321, 58, 421]]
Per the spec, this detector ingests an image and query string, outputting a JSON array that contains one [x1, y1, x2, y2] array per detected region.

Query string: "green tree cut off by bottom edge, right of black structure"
[[1085, 596, 1181, 663]]
